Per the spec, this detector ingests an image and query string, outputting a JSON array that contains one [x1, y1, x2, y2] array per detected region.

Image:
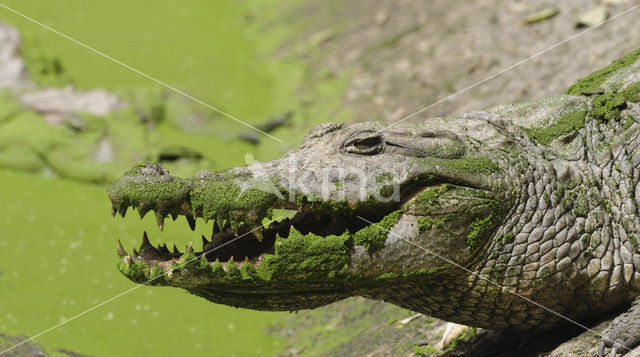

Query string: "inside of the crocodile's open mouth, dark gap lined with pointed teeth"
[[112, 179, 484, 275]]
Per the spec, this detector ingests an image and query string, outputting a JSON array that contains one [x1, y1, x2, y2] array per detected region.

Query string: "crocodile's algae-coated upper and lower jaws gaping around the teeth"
[[108, 164, 496, 291]]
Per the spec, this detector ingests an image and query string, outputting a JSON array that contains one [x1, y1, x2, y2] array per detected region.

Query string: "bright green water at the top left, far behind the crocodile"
[[0, 0, 302, 122]]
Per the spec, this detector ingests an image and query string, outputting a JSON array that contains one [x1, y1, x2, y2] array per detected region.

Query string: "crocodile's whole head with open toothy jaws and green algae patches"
[[108, 117, 514, 310]]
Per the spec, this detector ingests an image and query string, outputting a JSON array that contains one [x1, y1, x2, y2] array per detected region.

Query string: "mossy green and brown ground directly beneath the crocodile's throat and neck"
[[270, 298, 635, 357]]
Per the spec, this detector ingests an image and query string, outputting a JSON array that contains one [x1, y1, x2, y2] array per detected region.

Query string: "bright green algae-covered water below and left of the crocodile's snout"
[[0, 170, 281, 356]]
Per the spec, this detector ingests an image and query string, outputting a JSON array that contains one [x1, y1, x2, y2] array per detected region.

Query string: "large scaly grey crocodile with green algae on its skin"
[[108, 49, 640, 355]]
